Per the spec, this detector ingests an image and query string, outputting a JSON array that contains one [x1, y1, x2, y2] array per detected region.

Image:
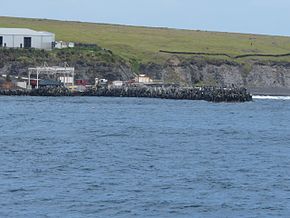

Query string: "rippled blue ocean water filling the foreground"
[[0, 97, 290, 217]]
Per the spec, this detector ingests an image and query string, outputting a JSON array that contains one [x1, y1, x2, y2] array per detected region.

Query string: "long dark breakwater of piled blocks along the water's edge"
[[0, 86, 252, 102]]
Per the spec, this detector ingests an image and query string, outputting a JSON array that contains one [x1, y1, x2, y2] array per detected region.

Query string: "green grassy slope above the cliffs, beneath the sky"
[[0, 17, 290, 63]]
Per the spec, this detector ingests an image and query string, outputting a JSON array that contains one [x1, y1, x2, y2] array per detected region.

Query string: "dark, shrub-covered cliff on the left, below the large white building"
[[0, 49, 134, 83]]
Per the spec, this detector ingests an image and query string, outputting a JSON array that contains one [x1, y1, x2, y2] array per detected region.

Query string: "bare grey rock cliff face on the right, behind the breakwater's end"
[[141, 57, 290, 94]]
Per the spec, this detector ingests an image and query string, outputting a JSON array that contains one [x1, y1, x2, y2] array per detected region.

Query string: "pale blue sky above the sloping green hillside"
[[0, 0, 290, 36]]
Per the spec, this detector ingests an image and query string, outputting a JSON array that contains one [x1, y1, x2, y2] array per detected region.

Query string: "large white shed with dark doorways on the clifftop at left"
[[0, 28, 55, 50]]
